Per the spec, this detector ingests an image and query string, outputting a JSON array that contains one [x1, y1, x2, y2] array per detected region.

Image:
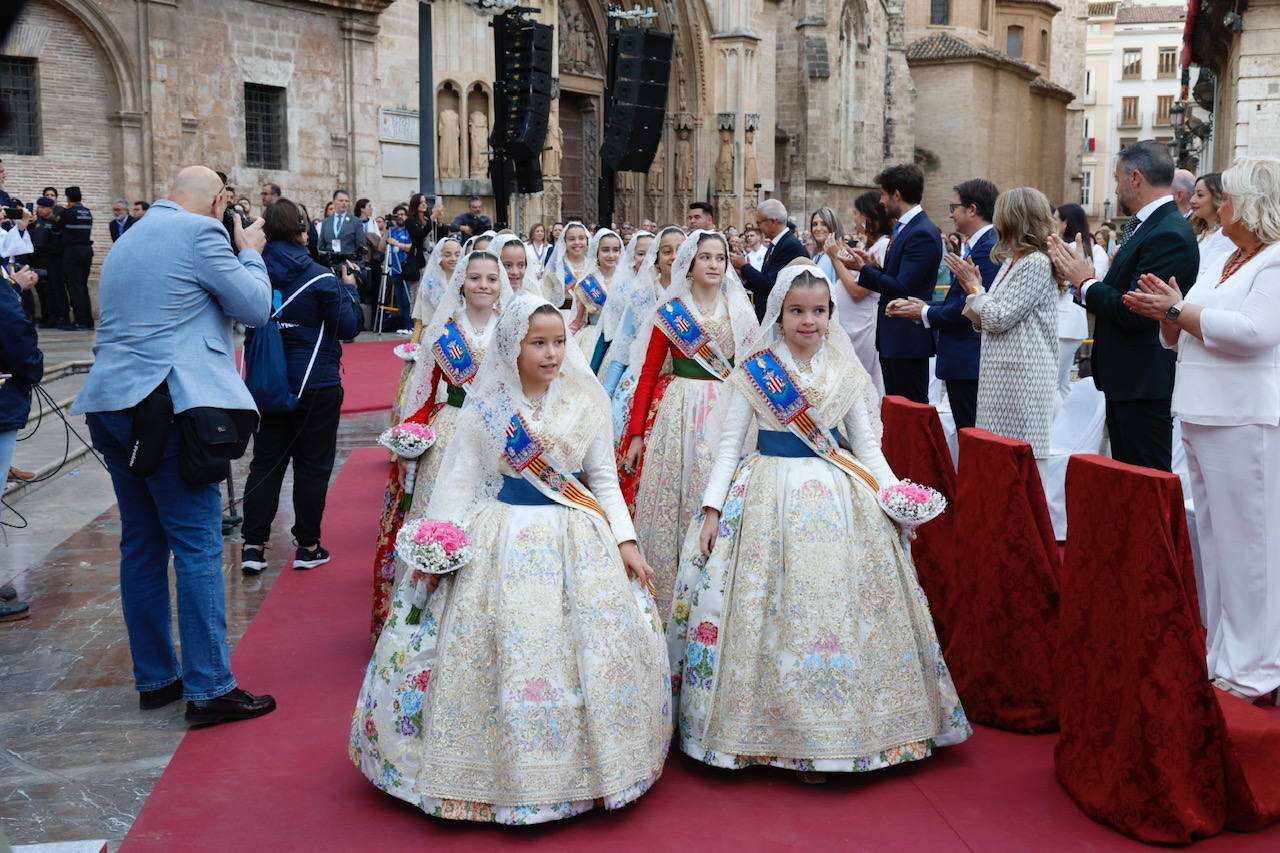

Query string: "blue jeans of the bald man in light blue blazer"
[[88, 411, 236, 701]]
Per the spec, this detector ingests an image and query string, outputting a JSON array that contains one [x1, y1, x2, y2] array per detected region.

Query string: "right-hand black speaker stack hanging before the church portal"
[[600, 28, 672, 172]]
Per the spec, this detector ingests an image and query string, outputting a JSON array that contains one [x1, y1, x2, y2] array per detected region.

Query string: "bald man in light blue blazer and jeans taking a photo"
[[72, 167, 275, 726]]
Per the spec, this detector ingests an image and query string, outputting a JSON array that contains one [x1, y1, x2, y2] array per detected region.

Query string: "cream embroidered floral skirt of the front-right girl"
[[667, 453, 972, 772]]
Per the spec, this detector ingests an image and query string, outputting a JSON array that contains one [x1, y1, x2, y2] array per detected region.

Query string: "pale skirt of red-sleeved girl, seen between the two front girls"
[[635, 377, 755, 620]]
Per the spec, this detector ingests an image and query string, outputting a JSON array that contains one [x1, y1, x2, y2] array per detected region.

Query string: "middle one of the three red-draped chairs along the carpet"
[[943, 429, 1060, 734]]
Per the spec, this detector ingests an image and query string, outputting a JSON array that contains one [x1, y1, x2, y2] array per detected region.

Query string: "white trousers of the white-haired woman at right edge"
[[1183, 421, 1280, 697]]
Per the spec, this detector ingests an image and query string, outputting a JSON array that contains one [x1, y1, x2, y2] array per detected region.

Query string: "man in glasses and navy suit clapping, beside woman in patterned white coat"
[[886, 178, 1000, 429]]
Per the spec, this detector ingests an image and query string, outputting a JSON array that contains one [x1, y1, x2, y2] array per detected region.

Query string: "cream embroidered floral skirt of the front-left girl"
[[351, 502, 671, 824]]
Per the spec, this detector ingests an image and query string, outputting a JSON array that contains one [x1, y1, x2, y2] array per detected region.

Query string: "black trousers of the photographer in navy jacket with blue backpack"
[[241, 386, 342, 546]]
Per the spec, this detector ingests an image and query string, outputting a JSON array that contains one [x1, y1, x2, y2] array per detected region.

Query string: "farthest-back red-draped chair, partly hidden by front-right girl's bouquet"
[[881, 397, 956, 643]]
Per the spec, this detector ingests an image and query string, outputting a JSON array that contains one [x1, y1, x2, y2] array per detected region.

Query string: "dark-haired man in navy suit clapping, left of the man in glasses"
[[841, 164, 942, 403]]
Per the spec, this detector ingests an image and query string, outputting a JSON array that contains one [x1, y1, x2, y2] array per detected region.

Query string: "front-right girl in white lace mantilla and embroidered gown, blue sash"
[[667, 261, 972, 781]]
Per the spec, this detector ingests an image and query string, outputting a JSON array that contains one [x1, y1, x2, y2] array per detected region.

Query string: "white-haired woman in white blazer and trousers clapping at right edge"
[[1125, 158, 1280, 703]]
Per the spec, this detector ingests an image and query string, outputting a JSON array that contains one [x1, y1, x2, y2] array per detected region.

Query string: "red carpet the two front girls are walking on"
[[123, 448, 1280, 853]]
